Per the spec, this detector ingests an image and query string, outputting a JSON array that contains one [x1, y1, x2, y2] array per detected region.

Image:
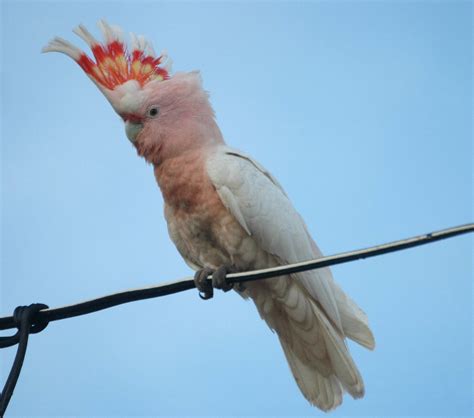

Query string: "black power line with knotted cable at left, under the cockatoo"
[[0, 223, 474, 417]]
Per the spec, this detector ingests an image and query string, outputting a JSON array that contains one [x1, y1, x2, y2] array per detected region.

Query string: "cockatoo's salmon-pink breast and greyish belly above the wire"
[[155, 151, 248, 268]]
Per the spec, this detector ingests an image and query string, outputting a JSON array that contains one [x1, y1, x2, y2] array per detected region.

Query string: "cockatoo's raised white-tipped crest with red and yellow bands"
[[42, 20, 171, 90]]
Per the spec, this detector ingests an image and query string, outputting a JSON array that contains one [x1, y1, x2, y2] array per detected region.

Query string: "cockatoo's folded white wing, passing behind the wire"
[[207, 147, 342, 331]]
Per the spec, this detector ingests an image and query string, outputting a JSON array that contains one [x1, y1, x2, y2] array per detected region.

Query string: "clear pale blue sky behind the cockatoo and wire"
[[0, 1, 473, 417]]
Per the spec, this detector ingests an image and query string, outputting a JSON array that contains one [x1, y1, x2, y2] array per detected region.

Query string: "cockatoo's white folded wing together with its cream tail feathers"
[[206, 146, 375, 410]]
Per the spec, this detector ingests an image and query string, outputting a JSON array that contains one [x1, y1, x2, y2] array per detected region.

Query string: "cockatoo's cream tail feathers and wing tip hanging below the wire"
[[252, 282, 374, 411]]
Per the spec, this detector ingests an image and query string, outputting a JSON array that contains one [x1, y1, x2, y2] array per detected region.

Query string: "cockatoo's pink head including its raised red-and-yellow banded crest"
[[42, 21, 223, 164]]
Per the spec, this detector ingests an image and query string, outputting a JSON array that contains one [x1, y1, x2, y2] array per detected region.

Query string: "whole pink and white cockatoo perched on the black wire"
[[43, 21, 375, 411]]
